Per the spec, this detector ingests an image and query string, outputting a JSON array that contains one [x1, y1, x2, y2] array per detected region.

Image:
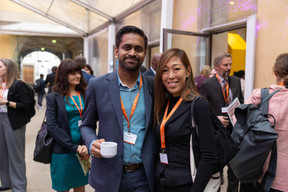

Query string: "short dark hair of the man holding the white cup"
[[116, 25, 148, 50]]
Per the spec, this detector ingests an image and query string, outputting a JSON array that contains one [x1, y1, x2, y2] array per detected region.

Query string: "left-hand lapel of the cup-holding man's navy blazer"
[[107, 71, 123, 131]]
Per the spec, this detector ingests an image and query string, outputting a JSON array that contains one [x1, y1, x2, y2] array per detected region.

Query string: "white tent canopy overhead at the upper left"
[[0, 0, 153, 37]]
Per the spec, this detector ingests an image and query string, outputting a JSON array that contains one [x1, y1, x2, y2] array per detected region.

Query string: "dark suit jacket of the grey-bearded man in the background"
[[199, 76, 244, 132]]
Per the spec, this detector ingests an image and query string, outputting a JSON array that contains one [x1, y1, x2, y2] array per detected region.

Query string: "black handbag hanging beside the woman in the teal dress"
[[33, 114, 53, 164]]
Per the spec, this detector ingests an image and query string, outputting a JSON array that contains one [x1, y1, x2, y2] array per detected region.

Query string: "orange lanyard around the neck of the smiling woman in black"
[[160, 97, 183, 150]]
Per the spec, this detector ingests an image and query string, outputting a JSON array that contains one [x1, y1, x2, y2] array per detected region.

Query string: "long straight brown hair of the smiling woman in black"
[[154, 48, 199, 124]]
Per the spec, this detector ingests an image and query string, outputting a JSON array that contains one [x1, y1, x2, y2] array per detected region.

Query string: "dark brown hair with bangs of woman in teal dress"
[[53, 59, 87, 97]]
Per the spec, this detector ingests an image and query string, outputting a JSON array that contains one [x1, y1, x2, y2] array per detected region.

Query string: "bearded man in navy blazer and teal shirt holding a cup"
[[81, 26, 157, 192]]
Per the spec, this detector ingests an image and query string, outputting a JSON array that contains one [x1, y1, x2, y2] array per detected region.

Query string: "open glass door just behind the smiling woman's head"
[[163, 29, 211, 77]]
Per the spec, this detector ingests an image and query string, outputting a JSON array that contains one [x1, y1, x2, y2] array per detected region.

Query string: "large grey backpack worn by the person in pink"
[[229, 89, 280, 191]]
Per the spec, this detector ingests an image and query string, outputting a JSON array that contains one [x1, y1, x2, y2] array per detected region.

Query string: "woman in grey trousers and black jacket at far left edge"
[[0, 59, 29, 192]]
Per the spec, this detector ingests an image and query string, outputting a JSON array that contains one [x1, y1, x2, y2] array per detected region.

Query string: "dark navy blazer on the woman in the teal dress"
[[46, 92, 78, 153]]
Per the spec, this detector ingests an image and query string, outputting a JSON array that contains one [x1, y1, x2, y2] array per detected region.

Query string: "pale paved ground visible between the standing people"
[[1, 99, 227, 192]]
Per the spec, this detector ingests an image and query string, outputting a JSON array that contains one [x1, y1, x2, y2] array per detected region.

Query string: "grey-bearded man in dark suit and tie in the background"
[[199, 53, 244, 192]]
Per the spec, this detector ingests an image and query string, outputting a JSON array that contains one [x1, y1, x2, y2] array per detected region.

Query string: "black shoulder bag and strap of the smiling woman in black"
[[191, 97, 239, 173]]
